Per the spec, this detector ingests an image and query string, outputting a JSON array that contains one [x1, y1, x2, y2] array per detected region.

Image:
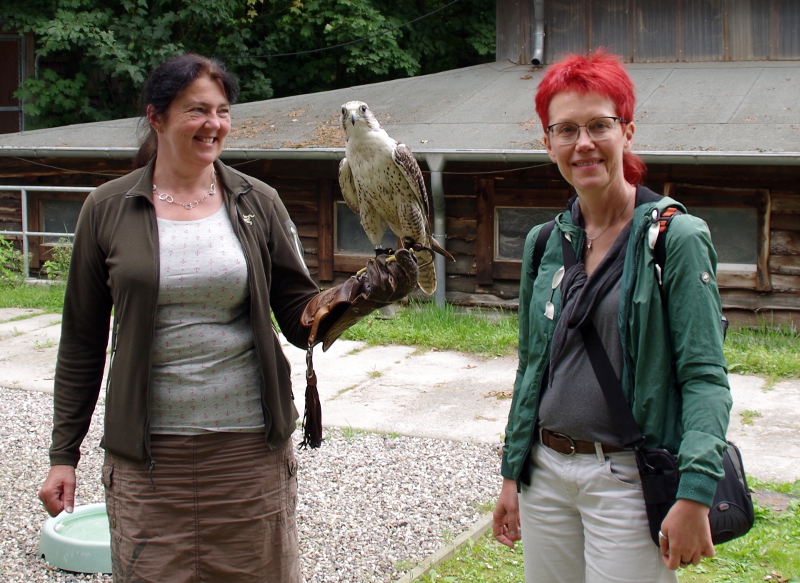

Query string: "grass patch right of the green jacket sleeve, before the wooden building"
[[725, 321, 800, 384]]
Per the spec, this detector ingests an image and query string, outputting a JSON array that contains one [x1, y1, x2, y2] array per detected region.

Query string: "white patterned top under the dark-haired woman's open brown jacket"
[[150, 205, 264, 434]]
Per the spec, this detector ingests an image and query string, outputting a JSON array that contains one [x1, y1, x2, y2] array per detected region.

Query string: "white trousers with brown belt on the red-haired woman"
[[519, 443, 678, 583]]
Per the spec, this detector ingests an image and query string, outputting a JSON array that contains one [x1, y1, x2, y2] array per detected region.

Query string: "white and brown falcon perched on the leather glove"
[[339, 101, 455, 294]]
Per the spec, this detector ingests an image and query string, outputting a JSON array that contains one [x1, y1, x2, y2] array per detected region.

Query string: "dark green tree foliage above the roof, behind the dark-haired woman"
[[0, 0, 495, 129]]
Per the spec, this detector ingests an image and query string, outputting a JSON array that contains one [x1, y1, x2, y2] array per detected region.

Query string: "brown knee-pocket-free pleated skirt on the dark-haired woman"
[[103, 433, 300, 583]]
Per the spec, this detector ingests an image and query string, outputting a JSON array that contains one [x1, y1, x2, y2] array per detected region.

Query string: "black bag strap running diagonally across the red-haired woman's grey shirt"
[[561, 234, 643, 447]]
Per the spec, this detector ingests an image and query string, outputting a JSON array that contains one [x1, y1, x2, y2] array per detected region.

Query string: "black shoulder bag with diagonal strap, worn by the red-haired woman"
[[561, 224, 755, 546]]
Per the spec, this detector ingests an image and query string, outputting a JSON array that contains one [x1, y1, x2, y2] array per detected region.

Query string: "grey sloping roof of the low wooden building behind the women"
[[0, 61, 800, 163]]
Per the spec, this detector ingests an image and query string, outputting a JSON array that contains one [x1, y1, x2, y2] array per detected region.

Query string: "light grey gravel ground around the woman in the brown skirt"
[[0, 388, 500, 583]]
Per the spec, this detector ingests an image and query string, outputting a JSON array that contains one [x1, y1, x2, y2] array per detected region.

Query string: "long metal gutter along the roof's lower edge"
[[0, 146, 800, 166]]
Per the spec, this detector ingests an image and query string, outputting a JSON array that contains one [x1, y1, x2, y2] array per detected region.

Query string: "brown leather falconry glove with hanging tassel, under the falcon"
[[300, 249, 419, 449]]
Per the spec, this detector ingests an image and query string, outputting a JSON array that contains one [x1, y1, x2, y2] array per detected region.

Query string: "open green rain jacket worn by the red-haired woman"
[[501, 186, 732, 506]]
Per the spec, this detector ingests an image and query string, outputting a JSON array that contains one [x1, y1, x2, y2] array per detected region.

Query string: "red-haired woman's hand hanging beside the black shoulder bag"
[[659, 499, 714, 571]]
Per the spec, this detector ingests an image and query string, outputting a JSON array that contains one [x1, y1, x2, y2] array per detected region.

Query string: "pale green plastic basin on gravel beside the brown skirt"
[[39, 503, 111, 573]]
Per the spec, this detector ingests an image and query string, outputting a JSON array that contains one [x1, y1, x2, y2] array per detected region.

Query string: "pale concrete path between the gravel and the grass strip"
[[0, 309, 800, 482]]
